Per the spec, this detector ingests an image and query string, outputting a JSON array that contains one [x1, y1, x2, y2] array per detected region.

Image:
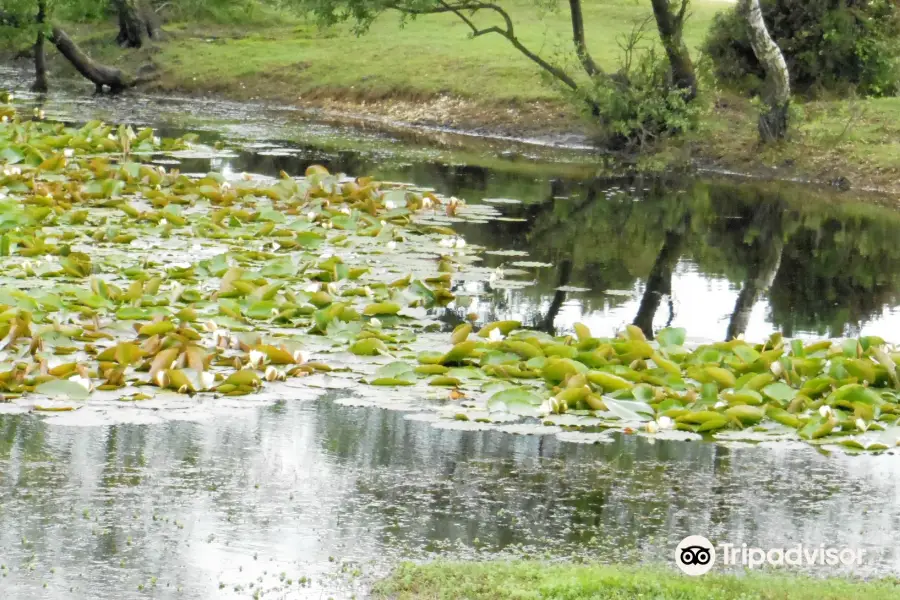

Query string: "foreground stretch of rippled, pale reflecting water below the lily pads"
[[0, 400, 900, 599]]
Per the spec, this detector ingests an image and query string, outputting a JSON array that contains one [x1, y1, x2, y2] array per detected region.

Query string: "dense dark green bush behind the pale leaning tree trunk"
[[704, 0, 900, 96]]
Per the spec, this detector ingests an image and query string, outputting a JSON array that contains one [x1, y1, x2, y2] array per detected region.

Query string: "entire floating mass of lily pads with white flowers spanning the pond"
[[0, 91, 900, 451]]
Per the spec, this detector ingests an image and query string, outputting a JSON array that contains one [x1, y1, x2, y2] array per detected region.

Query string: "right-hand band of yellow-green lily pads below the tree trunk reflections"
[[394, 321, 900, 451]]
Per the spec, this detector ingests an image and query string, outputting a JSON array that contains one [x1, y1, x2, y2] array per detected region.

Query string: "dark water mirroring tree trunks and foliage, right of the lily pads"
[[454, 179, 900, 340]]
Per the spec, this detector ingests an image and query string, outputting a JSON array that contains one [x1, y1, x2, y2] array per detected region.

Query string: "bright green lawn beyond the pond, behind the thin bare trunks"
[[153, 0, 723, 102]]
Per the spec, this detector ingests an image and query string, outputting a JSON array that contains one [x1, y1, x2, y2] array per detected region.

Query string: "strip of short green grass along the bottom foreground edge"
[[373, 562, 900, 600]]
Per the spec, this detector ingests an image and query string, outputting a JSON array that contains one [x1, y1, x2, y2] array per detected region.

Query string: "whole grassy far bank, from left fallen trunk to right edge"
[[17, 0, 900, 191]]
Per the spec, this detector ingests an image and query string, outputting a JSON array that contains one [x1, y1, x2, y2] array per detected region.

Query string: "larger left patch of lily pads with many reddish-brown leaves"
[[0, 98, 462, 410]]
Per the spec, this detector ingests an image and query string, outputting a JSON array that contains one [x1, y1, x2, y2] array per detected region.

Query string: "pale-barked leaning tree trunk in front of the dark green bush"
[[737, 0, 791, 142]]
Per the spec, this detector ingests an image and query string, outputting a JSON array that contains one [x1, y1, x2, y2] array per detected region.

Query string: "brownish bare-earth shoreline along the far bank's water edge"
[[10, 51, 900, 196]]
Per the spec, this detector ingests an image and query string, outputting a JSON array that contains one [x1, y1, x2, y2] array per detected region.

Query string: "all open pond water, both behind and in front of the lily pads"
[[0, 68, 900, 598]]
